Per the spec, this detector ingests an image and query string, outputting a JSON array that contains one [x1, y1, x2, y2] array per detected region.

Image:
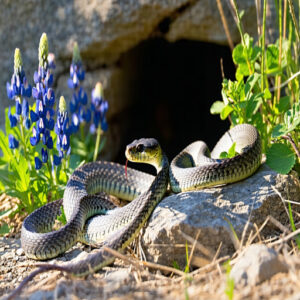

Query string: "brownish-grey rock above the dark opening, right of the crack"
[[166, 0, 276, 44]]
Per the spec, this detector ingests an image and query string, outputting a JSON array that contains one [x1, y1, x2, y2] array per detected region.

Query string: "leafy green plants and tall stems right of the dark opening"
[[210, 1, 300, 174]]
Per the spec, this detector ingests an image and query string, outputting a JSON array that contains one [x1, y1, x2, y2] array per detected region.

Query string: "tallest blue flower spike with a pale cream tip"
[[30, 33, 55, 169]]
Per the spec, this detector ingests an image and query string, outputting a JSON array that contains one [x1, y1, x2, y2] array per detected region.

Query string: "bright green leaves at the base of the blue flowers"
[[0, 109, 72, 213]]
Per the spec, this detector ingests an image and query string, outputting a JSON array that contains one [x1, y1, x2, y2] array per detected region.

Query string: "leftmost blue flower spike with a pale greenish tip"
[[6, 48, 31, 135]]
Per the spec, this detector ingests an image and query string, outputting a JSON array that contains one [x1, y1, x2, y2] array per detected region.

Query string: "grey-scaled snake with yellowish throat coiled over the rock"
[[21, 124, 262, 276]]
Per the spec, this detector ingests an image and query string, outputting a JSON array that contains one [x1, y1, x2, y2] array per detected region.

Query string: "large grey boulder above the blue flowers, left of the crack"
[[0, 0, 188, 124]]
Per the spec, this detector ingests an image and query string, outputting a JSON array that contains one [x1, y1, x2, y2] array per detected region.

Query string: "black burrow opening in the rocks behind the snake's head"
[[117, 39, 235, 172]]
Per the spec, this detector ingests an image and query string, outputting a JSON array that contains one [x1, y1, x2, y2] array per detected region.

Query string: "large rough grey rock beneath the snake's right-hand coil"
[[142, 165, 300, 267]]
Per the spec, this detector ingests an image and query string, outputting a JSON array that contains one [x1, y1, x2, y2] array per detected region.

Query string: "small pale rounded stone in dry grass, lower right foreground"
[[230, 244, 288, 286]]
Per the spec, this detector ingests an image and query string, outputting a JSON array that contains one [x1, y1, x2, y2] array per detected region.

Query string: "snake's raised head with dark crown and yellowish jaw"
[[125, 138, 163, 167]]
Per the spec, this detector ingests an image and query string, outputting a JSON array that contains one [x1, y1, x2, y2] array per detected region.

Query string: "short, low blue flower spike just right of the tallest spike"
[[53, 96, 72, 166]]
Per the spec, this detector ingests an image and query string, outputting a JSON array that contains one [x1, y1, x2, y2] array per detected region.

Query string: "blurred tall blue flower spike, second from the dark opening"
[[68, 43, 91, 132]]
